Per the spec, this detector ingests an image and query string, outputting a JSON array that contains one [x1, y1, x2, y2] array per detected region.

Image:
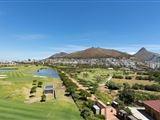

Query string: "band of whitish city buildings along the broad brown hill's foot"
[[44, 58, 137, 68]]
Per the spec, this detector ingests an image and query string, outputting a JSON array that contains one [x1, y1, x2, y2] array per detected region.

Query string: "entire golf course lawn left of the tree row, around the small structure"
[[0, 66, 82, 120]]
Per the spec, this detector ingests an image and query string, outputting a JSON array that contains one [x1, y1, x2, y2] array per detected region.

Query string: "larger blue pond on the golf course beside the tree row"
[[36, 68, 59, 78]]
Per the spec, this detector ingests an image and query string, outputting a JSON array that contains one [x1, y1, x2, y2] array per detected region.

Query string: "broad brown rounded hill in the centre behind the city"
[[50, 47, 130, 58]]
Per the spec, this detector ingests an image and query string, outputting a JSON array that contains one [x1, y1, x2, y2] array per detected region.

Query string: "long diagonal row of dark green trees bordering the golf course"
[[59, 70, 105, 120]]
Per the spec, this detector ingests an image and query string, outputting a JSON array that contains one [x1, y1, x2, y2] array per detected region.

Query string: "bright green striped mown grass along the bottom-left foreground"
[[0, 100, 80, 120]]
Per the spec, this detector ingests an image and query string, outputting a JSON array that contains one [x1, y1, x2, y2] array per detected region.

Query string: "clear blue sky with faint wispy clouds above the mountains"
[[0, 0, 160, 60]]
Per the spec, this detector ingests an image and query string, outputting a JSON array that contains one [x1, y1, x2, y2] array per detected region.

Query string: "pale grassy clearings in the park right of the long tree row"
[[77, 68, 156, 85]]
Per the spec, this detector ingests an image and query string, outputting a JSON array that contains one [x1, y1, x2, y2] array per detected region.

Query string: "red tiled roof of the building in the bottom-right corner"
[[143, 100, 160, 113]]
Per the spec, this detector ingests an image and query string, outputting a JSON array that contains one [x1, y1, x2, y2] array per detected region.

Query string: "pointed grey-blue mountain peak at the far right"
[[134, 47, 160, 62]]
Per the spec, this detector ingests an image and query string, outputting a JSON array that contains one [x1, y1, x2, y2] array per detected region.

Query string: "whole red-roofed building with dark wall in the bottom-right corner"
[[143, 100, 160, 120]]
